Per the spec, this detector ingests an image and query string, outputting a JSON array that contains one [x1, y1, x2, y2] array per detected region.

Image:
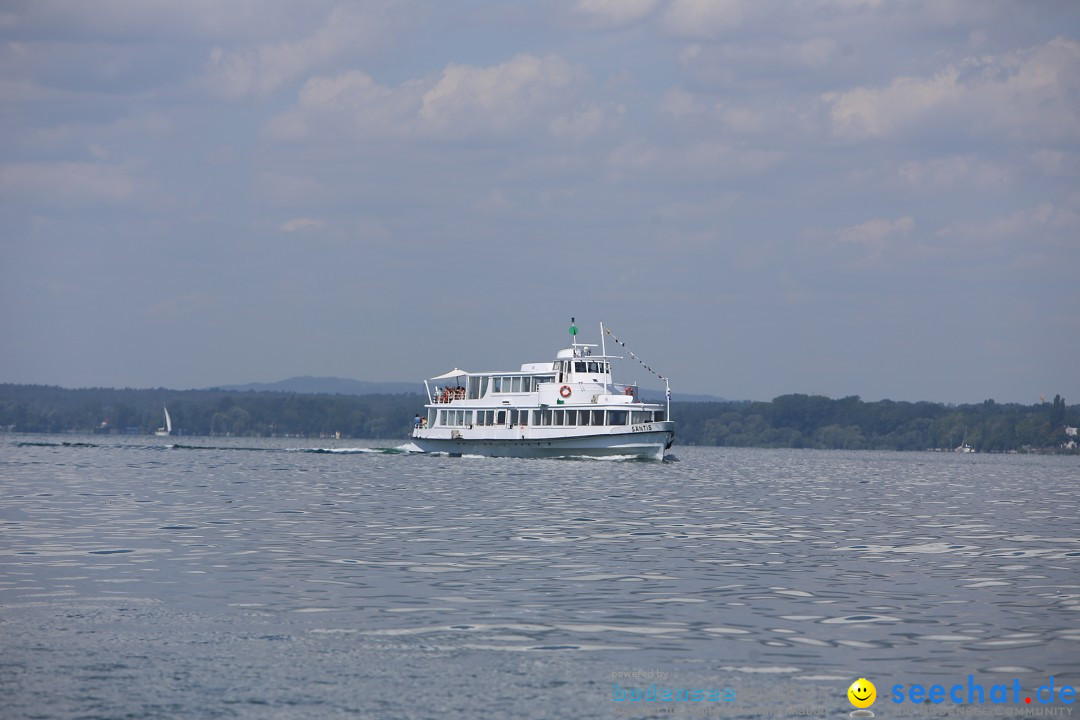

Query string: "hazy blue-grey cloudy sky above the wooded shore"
[[0, 0, 1080, 404]]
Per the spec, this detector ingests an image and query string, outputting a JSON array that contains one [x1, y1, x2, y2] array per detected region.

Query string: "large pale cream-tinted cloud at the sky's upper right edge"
[[822, 38, 1080, 140]]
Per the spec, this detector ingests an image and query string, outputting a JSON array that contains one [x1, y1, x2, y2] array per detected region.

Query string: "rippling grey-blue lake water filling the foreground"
[[0, 435, 1080, 720]]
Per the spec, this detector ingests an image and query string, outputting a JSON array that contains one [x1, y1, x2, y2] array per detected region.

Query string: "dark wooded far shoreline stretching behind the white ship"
[[0, 384, 1080, 452]]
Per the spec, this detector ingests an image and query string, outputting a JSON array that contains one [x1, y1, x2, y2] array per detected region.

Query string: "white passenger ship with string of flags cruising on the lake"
[[413, 321, 675, 460]]
